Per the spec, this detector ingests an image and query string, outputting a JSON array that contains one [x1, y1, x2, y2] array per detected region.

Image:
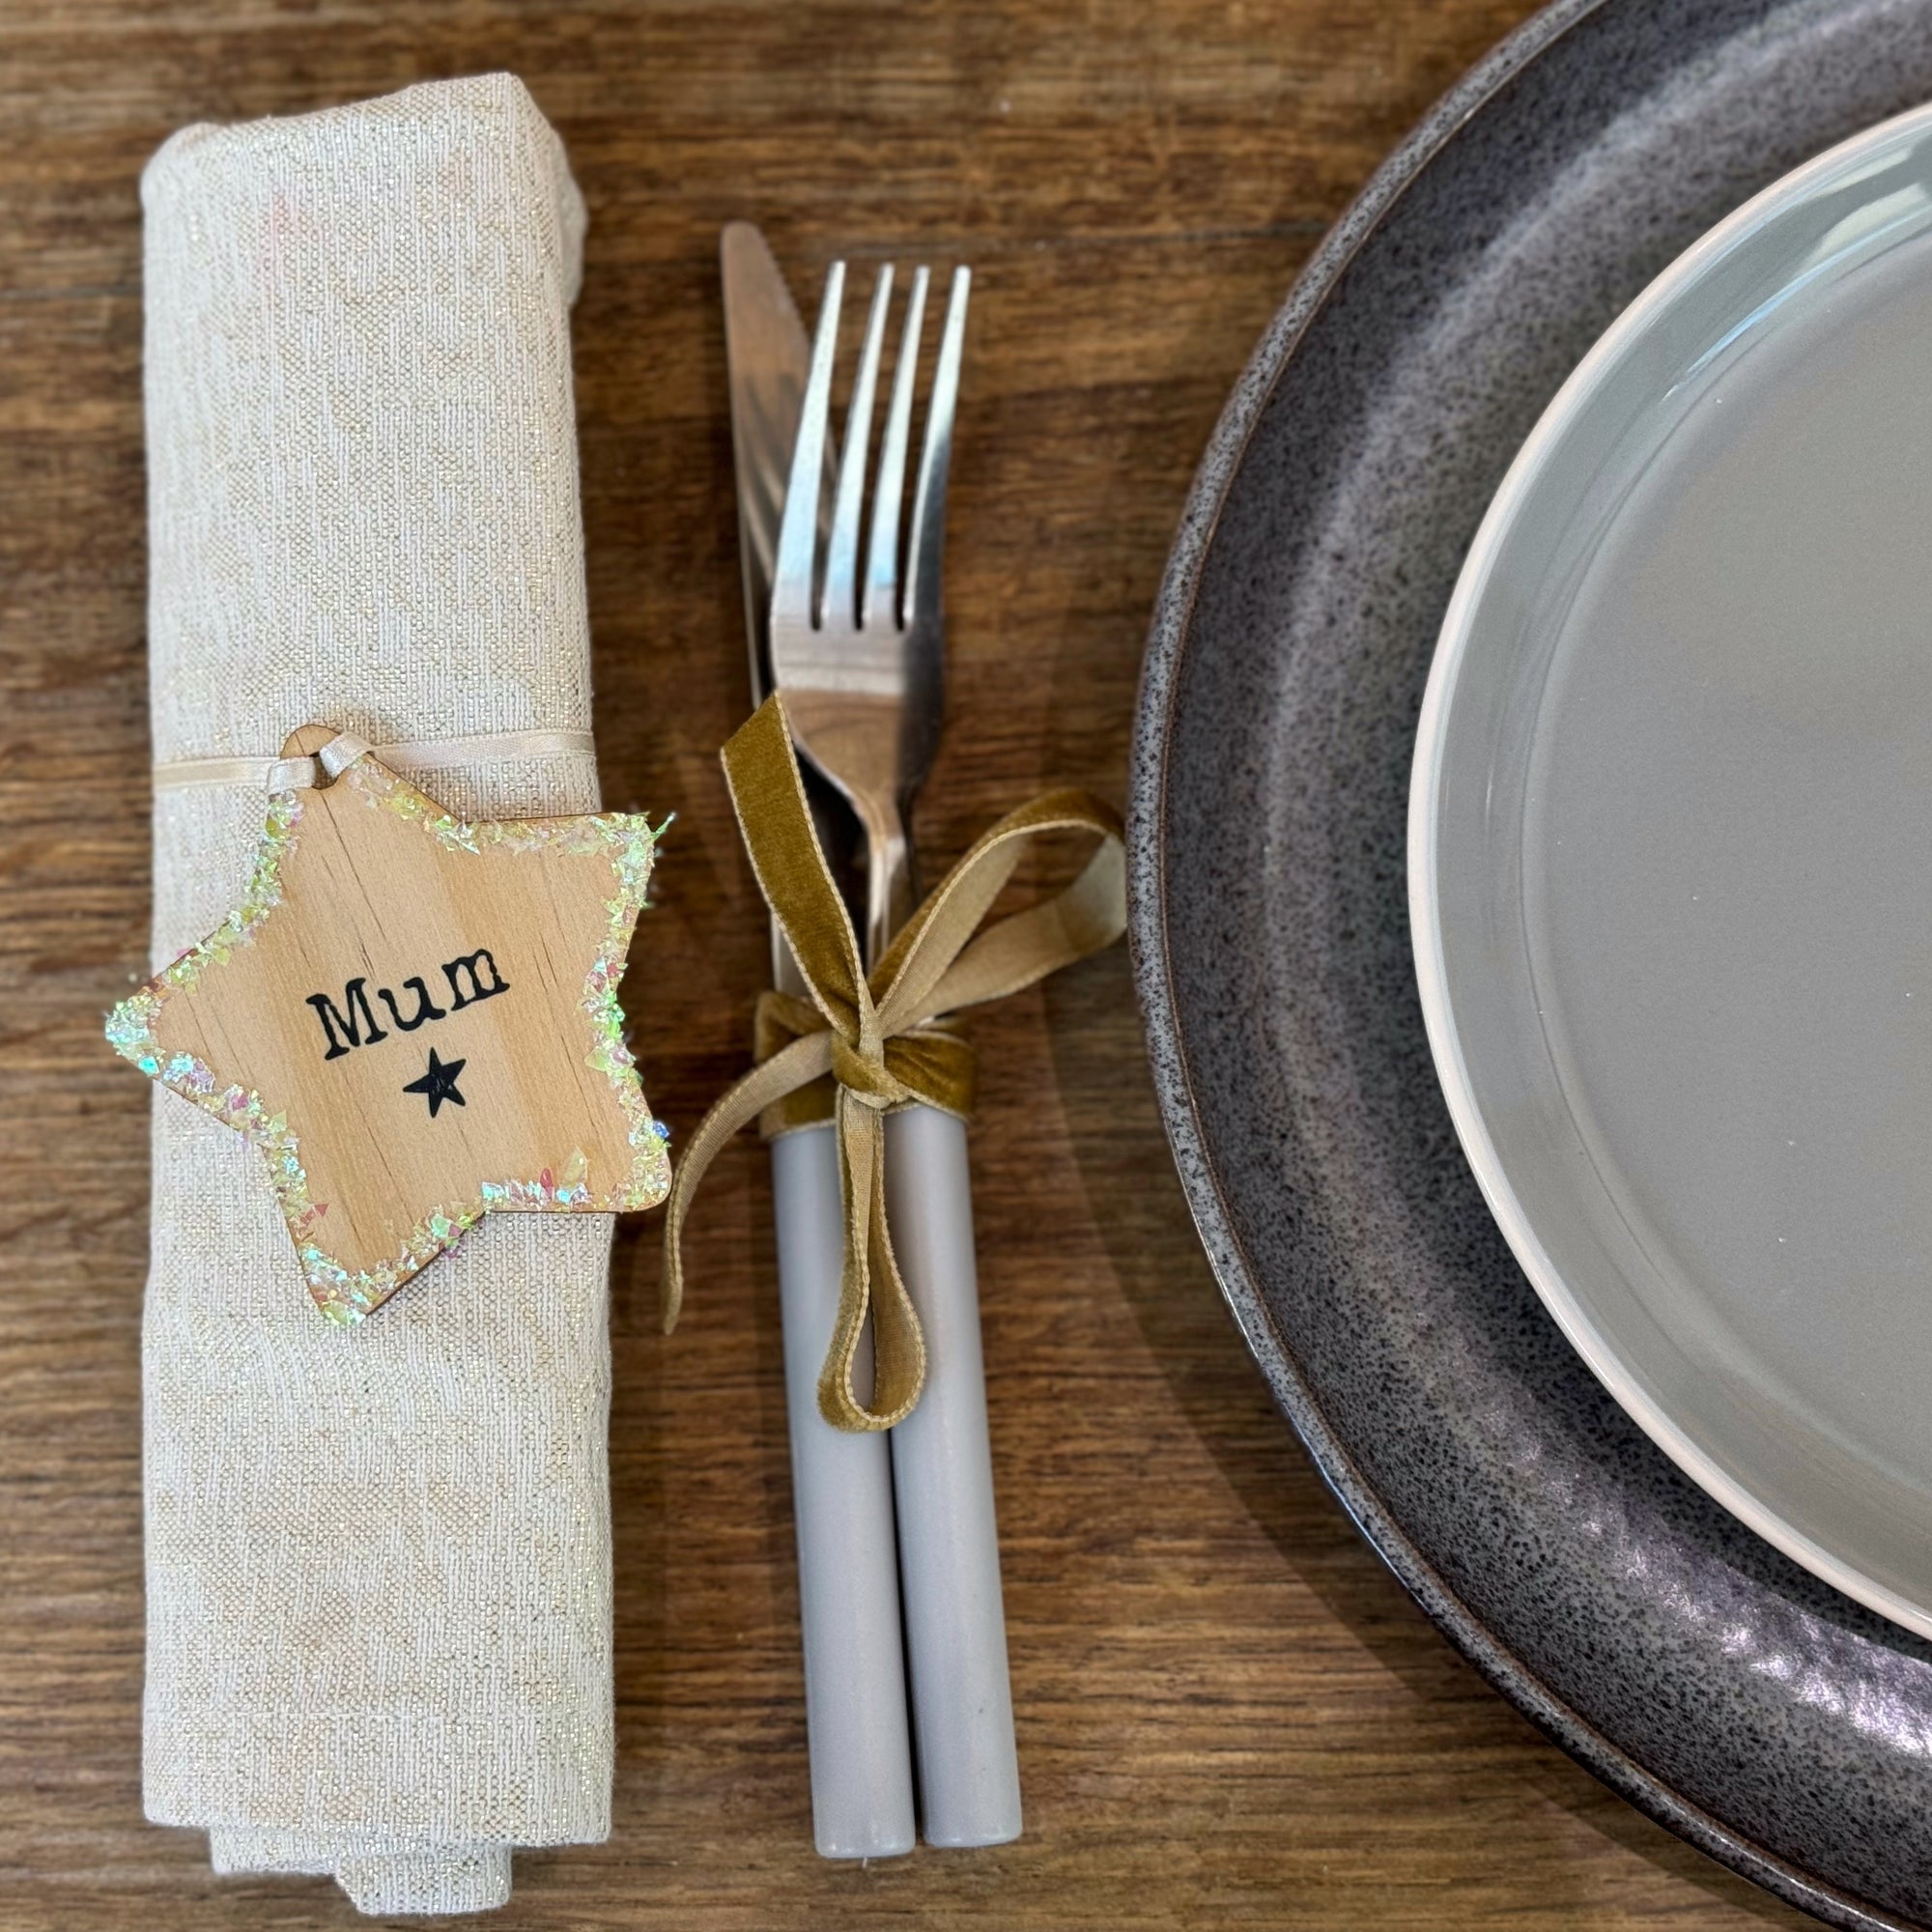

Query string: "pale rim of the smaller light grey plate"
[[1406, 102, 1932, 1638]]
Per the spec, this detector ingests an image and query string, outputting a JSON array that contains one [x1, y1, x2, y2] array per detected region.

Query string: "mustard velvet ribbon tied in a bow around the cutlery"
[[665, 696, 1126, 1432]]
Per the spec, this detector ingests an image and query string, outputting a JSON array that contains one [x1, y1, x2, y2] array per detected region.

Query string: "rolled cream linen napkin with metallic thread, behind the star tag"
[[143, 75, 612, 1913]]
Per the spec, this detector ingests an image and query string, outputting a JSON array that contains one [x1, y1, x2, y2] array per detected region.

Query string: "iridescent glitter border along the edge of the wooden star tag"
[[106, 757, 670, 1325]]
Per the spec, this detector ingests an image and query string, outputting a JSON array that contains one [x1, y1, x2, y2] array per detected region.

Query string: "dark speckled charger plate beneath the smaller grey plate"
[[1132, 0, 1932, 1926]]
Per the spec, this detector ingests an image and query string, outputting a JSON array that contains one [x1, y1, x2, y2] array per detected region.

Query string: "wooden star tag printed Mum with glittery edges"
[[108, 724, 670, 1321]]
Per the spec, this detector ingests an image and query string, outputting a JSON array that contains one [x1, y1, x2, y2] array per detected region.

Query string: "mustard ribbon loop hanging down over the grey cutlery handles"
[[819, 1092, 925, 1434]]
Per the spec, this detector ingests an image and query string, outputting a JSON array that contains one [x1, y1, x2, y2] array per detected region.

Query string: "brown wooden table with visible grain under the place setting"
[[0, 0, 1801, 1932]]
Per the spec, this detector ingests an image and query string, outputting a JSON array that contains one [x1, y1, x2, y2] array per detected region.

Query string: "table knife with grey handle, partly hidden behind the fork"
[[719, 222, 916, 1859]]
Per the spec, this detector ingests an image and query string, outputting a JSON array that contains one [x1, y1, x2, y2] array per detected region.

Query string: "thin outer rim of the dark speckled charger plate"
[[1126, 0, 1917, 1932]]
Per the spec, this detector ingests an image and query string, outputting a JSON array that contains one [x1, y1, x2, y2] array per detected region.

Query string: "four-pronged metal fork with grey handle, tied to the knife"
[[771, 263, 1020, 1845]]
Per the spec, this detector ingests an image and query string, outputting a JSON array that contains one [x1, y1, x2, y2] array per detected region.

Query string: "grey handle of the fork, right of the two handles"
[[885, 1107, 1020, 1845]]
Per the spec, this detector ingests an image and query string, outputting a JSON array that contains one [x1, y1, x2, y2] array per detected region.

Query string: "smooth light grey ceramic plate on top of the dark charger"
[[1408, 98, 1932, 1634]]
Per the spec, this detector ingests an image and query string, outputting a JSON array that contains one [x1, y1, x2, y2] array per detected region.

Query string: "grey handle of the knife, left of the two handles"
[[771, 1122, 916, 1859]]
